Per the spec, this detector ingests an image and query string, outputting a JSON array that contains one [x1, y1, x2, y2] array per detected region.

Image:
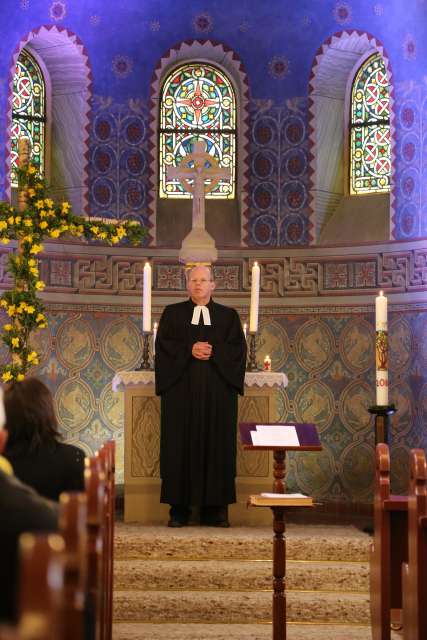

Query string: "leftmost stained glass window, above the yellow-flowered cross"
[[11, 49, 46, 187]]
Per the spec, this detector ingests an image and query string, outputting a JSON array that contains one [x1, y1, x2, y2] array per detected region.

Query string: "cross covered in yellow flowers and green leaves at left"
[[0, 164, 146, 382]]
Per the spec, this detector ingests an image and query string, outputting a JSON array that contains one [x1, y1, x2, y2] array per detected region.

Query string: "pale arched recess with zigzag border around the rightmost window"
[[308, 30, 395, 244]]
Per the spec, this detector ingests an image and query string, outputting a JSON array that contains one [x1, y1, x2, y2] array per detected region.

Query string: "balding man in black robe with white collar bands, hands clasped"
[[156, 266, 246, 527]]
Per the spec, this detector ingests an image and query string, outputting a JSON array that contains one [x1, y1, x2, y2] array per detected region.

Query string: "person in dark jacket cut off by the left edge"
[[0, 387, 58, 623]]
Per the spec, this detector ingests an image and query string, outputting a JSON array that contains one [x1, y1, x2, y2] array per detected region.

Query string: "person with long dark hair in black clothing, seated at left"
[[4, 378, 84, 501]]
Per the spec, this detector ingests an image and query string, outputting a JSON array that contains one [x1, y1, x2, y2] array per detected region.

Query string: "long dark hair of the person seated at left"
[[4, 378, 60, 451]]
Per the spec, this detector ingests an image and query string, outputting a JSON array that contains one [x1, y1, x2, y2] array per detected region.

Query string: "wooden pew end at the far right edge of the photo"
[[402, 449, 427, 640]]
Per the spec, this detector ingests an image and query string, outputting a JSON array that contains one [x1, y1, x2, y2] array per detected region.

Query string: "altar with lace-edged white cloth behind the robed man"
[[112, 371, 288, 525]]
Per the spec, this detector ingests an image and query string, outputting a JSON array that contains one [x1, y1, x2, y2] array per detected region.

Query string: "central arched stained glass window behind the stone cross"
[[159, 63, 236, 199]]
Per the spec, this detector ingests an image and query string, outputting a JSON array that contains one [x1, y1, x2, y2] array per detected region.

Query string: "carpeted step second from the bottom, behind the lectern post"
[[113, 590, 370, 625]]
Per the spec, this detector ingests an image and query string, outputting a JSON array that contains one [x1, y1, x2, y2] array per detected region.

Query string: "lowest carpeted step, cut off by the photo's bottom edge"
[[113, 622, 401, 640]]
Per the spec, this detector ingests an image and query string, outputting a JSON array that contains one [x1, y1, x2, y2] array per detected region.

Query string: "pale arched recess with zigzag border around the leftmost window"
[[5, 25, 92, 214]]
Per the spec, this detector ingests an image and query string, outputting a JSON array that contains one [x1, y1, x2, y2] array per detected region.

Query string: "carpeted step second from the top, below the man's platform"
[[114, 560, 369, 592]]
